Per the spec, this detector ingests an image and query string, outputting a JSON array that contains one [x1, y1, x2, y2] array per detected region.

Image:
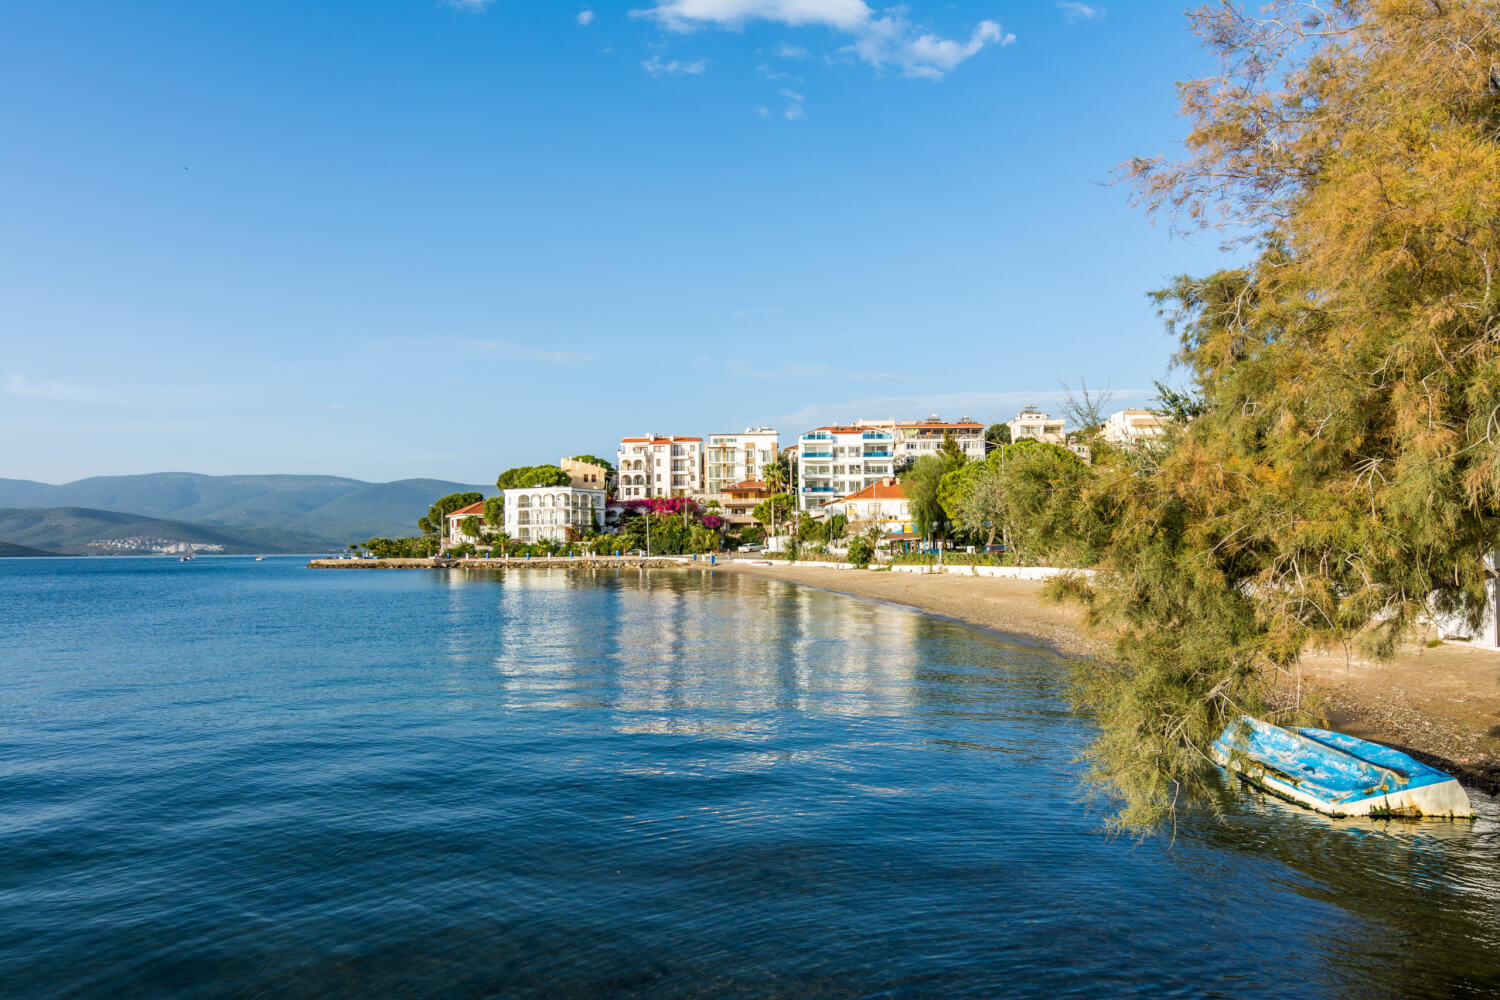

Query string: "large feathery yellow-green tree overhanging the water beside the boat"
[[1077, 0, 1500, 829]]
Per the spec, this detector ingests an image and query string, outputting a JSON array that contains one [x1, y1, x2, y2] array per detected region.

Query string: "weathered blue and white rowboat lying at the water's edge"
[[1212, 715, 1475, 819]]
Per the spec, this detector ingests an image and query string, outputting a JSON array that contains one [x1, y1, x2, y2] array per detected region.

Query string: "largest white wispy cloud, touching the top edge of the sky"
[[630, 0, 1016, 79]]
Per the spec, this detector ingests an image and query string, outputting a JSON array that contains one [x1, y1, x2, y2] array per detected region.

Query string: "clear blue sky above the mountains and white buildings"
[[0, 0, 1229, 483]]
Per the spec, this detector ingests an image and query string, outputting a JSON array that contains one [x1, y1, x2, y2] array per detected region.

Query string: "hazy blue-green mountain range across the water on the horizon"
[[0, 472, 495, 555]]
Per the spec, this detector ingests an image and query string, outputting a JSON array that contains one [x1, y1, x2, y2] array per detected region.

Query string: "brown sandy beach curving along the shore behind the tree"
[[717, 561, 1500, 793]]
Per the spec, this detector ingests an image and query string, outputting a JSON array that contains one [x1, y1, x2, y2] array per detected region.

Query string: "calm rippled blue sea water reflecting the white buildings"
[[0, 558, 1500, 999]]
